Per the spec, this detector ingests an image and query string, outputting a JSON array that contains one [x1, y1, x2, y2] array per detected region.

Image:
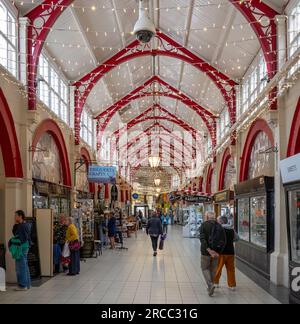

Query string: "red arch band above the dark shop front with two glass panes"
[[240, 119, 274, 182]]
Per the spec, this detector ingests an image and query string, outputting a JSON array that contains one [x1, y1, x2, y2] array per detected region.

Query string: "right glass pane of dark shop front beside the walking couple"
[[250, 196, 267, 248]]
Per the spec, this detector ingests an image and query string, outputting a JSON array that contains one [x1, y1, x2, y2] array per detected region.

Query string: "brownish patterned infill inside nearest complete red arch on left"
[[32, 133, 63, 184]]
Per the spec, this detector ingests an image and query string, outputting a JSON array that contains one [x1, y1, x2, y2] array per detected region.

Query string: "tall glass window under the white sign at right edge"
[[288, 189, 300, 263]]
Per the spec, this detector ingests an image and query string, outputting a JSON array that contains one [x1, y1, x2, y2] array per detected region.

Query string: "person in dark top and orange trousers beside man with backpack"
[[215, 216, 239, 291]]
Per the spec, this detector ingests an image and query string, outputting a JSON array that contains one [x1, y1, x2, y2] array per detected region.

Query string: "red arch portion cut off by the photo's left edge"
[[0, 89, 23, 178]]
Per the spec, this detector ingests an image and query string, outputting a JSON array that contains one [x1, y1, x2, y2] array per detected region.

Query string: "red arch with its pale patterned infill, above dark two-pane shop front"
[[240, 119, 274, 182]]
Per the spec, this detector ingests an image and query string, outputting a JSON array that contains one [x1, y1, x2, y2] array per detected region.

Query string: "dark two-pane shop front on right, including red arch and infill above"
[[234, 119, 275, 279]]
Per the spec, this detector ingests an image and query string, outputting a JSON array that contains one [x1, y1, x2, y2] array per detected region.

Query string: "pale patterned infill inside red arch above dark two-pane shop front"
[[248, 132, 274, 179]]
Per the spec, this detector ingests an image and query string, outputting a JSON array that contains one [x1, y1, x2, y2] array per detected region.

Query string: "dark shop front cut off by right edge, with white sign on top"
[[280, 154, 300, 304]]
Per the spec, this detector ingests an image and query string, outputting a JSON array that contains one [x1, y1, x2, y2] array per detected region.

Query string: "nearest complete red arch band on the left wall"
[[32, 119, 72, 187]]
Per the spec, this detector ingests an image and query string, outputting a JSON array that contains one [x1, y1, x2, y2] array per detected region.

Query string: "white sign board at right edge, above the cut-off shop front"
[[280, 154, 300, 184]]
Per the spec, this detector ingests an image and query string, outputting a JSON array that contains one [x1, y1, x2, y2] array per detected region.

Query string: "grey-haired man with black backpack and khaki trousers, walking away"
[[200, 212, 226, 297]]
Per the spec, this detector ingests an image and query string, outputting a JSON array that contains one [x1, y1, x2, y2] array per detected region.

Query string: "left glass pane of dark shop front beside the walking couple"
[[238, 198, 250, 242]]
